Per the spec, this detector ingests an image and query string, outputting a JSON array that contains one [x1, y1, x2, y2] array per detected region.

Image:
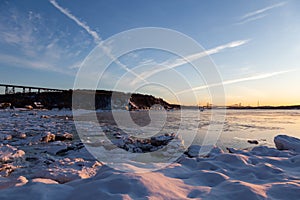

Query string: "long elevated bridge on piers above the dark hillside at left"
[[0, 84, 66, 94]]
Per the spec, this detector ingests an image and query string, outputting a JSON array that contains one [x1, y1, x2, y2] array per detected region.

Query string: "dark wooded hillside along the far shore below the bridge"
[[0, 90, 180, 110]]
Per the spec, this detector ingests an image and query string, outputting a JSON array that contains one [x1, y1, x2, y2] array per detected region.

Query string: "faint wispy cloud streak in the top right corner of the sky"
[[236, 2, 287, 25]]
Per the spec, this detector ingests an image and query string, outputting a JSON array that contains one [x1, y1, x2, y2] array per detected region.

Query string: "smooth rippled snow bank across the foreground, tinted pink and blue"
[[0, 136, 300, 200]]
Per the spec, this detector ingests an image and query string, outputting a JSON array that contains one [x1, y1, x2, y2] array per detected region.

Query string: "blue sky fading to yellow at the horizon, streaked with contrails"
[[0, 0, 300, 106]]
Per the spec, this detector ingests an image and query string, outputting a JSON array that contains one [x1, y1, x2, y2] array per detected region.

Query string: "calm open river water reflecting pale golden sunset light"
[[71, 109, 300, 149]]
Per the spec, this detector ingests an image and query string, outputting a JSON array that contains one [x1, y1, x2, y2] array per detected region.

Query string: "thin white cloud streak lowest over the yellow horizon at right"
[[176, 69, 296, 94]]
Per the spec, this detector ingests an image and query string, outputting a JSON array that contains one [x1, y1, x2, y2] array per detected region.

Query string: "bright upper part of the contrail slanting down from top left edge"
[[50, 0, 102, 44]]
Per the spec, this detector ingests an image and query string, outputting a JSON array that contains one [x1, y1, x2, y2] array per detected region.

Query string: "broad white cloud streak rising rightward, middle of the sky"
[[131, 39, 250, 85]]
